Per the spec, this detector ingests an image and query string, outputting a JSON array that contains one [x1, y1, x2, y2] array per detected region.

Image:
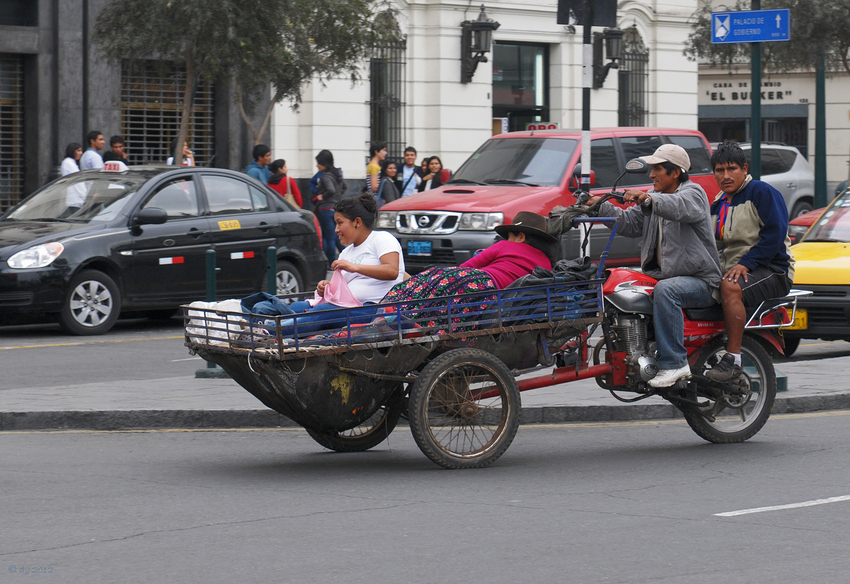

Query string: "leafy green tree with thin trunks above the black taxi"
[[95, 0, 399, 155]]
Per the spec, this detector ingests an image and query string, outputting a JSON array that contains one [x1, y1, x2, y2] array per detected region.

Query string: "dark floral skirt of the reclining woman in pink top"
[[381, 267, 496, 335]]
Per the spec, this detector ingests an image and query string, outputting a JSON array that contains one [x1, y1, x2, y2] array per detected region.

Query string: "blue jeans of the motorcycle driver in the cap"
[[652, 276, 715, 369]]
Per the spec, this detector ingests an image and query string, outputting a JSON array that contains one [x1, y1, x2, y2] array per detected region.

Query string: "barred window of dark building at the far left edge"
[[0, 55, 24, 214]]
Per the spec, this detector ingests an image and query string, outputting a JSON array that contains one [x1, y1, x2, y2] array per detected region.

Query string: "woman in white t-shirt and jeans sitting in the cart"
[[281, 193, 404, 334]]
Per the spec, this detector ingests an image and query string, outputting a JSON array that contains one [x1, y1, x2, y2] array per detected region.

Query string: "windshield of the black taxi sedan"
[[6, 173, 146, 223]]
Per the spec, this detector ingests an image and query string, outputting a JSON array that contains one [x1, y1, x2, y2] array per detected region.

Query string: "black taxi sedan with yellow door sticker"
[[0, 163, 327, 335]]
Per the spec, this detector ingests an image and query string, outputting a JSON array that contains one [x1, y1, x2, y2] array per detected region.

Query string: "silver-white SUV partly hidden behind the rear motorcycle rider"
[[741, 142, 815, 219]]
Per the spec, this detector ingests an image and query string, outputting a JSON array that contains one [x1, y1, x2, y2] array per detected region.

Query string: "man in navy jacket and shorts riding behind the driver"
[[706, 140, 794, 384]]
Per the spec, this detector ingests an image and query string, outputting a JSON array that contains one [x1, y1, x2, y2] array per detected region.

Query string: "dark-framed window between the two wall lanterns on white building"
[[493, 42, 550, 132]]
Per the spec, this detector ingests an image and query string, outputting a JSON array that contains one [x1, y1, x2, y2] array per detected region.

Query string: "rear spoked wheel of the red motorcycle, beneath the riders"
[[682, 336, 776, 444]]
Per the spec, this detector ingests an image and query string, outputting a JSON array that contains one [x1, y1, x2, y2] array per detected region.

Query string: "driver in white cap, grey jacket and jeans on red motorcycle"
[[588, 144, 721, 387]]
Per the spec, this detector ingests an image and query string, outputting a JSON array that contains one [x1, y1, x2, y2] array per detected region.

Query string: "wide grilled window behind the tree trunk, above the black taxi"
[[121, 61, 215, 166]]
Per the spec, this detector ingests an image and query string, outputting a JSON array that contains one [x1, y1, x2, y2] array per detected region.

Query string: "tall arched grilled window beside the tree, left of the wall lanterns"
[[369, 39, 407, 160]]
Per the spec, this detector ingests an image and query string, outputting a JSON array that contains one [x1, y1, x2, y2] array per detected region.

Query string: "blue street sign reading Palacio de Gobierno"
[[711, 8, 791, 44]]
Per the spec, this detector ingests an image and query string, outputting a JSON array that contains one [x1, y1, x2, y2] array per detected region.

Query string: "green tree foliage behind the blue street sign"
[[685, 0, 850, 74]]
